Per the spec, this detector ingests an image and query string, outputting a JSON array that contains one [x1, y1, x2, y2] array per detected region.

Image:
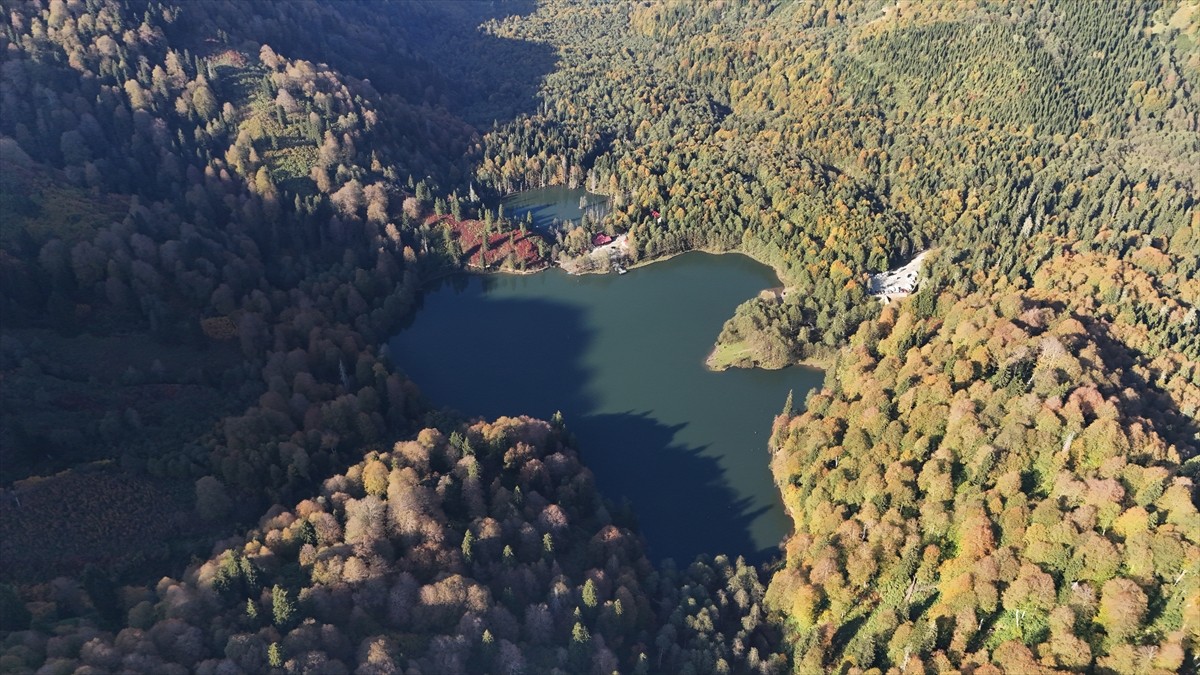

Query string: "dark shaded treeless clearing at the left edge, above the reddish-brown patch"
[[0, 326, 241, 484]]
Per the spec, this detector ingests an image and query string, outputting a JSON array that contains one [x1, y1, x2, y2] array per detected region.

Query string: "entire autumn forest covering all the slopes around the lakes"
[[0, 0, 1200, 674]]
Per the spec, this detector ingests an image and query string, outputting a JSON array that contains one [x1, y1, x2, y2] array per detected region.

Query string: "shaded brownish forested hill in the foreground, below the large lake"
[[0, 418, 787, 674]]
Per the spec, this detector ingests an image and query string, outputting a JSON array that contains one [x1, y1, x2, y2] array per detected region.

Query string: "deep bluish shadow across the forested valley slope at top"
[[188, 0, 557, 129]]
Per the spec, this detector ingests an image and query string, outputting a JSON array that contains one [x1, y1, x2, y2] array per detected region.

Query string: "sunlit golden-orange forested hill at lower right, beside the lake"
[[768, 255, 1200, 674]]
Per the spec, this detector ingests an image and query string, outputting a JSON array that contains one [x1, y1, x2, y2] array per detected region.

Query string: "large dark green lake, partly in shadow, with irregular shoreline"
[[389, 252, 823, 565]]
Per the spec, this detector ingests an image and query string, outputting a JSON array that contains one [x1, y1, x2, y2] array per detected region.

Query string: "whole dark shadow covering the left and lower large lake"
[[389, 276, 775, 565]]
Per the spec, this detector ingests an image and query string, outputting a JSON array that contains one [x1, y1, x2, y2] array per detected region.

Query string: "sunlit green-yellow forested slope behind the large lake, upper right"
[[479, 1, 1200, 366]]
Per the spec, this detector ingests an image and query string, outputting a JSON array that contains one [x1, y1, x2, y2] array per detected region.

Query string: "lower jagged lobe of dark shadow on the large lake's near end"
[[566, 411, 775, 565]]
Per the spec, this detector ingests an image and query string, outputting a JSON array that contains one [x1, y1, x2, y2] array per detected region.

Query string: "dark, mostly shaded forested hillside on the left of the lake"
[[0, 1, 544, 617]]
